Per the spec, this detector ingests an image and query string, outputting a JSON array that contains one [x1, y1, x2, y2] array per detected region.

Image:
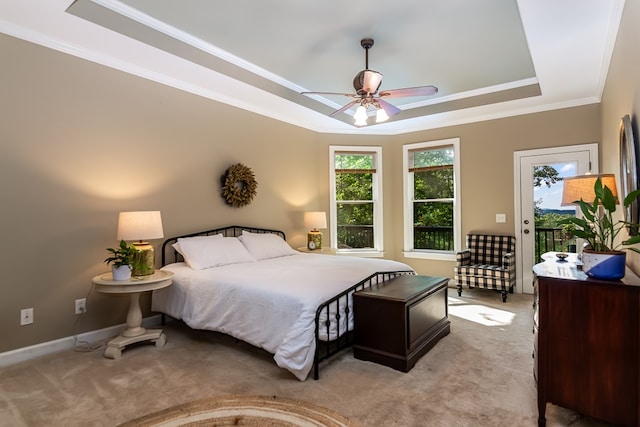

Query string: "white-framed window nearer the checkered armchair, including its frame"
[[403, 138, 460, 260]]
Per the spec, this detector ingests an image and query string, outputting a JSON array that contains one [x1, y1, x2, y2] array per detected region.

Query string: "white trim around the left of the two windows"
[[329, 145, 384, 257]]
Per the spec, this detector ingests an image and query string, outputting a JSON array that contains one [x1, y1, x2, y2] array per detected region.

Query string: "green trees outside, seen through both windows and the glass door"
[[335, 158, 575, 254]]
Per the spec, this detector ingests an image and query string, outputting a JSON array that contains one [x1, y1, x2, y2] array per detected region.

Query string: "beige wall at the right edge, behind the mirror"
[[601, 1, 640, 273]]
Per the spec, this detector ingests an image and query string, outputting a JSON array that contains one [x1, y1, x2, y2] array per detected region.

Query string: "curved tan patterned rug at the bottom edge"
[[121, 395, 358, 427]]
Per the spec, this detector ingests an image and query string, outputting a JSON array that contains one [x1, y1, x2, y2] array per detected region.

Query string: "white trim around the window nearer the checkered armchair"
[[402, 138, 462, 261]]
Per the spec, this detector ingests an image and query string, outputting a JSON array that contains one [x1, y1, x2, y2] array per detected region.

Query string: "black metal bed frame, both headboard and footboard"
[[162, 225, 415, 380]]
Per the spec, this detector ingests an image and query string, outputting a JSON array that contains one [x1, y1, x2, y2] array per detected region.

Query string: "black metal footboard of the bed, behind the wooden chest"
[[313, 270, 415, 380]]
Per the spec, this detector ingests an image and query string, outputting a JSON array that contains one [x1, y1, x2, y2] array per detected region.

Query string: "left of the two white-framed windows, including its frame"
[[329, 146, 382, 253]]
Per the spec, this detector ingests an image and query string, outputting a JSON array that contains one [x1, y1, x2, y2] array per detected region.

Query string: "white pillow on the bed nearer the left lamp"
[[178, 237, 256, 270]]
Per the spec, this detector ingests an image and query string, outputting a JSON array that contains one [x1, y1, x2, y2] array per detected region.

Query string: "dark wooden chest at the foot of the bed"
[[353, 275, 450, 372]]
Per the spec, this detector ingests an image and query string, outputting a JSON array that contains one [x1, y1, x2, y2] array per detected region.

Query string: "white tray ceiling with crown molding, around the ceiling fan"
[[0, 0, 624, 134]]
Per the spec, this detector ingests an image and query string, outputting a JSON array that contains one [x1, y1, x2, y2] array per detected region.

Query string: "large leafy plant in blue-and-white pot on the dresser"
[[560, 178, 640, 280]]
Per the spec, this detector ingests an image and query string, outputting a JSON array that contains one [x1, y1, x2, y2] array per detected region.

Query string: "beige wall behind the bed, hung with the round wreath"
[[0, 36, 319, 352]]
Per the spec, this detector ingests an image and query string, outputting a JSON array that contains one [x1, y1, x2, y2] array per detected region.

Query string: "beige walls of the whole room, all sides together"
[[5, 2, 640, 352]]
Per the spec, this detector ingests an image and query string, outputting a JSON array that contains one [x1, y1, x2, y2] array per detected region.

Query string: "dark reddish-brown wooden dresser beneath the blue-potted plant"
[[533, 254, 640, 426]]
